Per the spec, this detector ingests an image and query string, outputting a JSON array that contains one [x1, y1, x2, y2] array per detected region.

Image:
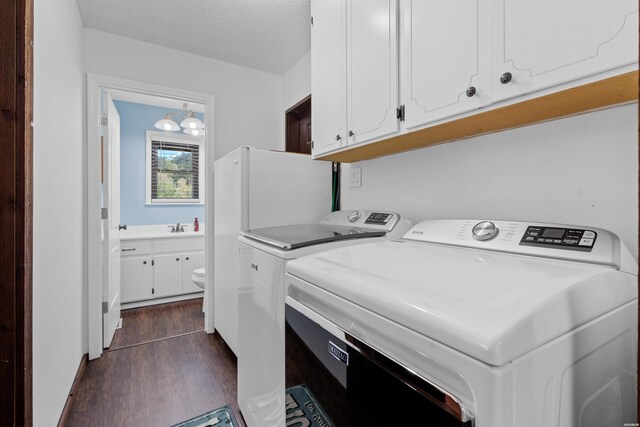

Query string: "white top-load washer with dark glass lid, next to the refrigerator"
[[238, 211, 412, 427]]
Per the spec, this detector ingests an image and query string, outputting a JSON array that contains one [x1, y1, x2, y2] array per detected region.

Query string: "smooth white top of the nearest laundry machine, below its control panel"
[[286, 240, 637, 366]]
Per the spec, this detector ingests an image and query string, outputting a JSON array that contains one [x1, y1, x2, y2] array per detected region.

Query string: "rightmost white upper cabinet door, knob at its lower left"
[[492, 0, 638, 100]]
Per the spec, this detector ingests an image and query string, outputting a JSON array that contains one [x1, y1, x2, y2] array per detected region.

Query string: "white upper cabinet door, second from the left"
[[348, 0, 399, 145]]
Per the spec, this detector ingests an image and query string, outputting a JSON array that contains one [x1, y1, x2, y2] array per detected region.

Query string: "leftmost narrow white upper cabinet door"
[[311, 0, 347, 156]]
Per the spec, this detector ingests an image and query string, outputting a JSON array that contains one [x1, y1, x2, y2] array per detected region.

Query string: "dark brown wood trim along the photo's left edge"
[[0, 0, 33, 426]]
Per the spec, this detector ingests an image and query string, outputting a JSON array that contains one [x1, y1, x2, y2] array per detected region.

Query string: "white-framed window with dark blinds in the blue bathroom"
[[148, 138, 201, 203]]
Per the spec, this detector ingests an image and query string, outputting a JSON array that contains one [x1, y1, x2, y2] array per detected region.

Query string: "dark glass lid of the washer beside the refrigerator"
[[240, 224, 386, 249]]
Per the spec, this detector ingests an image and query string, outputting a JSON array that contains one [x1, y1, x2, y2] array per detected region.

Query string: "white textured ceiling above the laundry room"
[[77, 0, 311, 74]]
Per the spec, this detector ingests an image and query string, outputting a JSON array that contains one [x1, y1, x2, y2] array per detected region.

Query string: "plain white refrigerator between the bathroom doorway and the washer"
[[215, 147, 332, 355]]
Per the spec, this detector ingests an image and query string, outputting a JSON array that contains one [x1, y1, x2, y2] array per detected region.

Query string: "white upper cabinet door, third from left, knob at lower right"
[[400, 0, 491, 128]]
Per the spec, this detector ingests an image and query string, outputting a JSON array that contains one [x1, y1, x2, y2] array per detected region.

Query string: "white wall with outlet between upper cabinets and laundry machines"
[[341, 104, 638, 259]]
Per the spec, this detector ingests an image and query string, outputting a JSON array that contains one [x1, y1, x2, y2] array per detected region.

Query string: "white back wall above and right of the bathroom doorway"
[[83, 28, 284, 159]]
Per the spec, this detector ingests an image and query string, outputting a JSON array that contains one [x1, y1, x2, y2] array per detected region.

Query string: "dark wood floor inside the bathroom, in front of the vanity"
[[109, 298, 204, 350]]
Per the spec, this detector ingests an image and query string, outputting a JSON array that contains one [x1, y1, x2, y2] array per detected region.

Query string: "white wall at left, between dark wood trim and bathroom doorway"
[[33, 0, 86, 426]]
